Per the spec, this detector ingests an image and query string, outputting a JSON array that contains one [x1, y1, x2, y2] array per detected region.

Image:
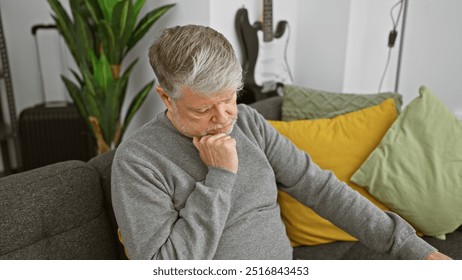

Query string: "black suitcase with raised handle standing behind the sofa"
[[18, 25, 96, 171]]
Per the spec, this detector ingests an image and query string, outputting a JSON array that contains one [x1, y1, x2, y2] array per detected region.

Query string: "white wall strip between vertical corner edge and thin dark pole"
[[343, 0, 403, 93]]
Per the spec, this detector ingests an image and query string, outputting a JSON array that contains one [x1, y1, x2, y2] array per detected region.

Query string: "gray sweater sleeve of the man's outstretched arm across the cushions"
[[251, 107, 436, 259]]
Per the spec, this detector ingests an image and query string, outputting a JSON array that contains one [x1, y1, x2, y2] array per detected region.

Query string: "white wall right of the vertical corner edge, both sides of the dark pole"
[[343, 0, 462, 116]]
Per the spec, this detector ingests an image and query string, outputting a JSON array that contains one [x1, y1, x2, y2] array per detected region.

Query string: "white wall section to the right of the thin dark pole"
[[399, 0, 462, 114]]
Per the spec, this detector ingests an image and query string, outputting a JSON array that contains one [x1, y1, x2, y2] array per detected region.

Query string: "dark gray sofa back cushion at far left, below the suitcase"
[[0, 161, 116, 259]]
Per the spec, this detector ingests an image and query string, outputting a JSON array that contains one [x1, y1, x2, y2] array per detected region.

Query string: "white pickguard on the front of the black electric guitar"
[[254, 21, 292, 86]]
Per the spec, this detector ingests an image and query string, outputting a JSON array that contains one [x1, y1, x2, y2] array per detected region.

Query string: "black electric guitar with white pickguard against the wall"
[[236, 0, 292, 103]]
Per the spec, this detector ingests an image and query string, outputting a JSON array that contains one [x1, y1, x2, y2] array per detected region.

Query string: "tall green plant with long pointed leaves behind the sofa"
[[48, 0, 175, 154]]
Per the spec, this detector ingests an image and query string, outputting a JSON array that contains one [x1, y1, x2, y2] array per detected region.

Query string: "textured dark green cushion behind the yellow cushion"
[[281, 85, 403, 121]]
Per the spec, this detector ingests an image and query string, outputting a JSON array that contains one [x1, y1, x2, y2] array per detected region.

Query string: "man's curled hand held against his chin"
[[193, 133, 238, 173]]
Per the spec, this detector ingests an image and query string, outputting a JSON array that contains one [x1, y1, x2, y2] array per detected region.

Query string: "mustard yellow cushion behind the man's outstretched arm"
[[269, 99, 397, 246]]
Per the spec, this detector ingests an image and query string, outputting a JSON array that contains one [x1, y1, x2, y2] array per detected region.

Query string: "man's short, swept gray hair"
[[149, 25, 243, 99]]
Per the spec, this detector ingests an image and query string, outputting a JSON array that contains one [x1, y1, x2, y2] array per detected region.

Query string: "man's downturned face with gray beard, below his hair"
[[162, 86, 237, 138]]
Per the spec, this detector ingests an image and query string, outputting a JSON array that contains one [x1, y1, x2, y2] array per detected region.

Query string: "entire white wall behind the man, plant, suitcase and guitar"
[[0, 0, 462, 173]]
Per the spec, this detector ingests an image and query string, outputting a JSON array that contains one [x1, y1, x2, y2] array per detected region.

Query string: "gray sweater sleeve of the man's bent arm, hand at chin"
[[112, 155, 235, 259]]
